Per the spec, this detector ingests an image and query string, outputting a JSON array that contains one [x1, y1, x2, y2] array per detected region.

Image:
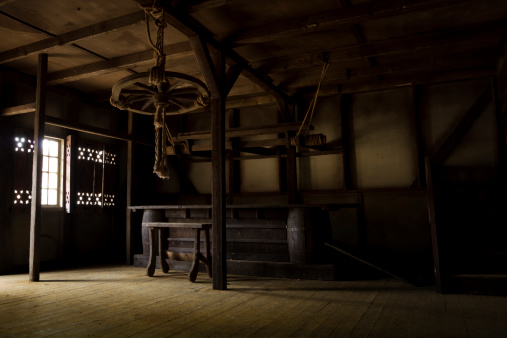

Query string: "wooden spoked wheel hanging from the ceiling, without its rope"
[[110, 72, 209, 115]]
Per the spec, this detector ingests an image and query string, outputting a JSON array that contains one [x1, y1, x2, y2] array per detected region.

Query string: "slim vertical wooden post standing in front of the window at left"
[[29, 54, 48, 282]]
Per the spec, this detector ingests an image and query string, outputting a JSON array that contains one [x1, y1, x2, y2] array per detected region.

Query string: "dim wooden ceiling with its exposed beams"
[[0, 0, 507, 107]]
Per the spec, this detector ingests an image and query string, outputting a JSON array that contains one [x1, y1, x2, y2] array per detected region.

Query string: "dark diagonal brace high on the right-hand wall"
[[431, 85, 492, 166]]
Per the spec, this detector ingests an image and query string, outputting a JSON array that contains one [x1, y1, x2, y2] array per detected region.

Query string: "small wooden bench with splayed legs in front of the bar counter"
[[142, 222, 212, 283]]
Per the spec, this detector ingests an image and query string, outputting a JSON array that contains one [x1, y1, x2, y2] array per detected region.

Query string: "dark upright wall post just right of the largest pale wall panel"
[[412, 85, 426, 188]]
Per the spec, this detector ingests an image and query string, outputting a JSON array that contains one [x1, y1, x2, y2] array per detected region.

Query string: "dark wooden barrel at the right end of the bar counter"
[[287, 208, 313, 264]]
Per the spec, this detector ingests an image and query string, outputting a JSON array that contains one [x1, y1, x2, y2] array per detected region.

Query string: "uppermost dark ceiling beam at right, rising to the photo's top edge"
[[230, 0, 466, 47]]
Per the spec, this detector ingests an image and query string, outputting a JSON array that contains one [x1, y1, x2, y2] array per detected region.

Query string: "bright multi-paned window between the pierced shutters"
[[41, 137, 63, 207]]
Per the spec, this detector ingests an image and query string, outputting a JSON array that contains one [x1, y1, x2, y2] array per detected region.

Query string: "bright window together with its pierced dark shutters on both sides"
[[13, 132, 117, 212]]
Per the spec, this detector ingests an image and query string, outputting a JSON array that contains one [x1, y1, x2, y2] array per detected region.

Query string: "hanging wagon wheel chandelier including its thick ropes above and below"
[[109, 0, 210, 178]]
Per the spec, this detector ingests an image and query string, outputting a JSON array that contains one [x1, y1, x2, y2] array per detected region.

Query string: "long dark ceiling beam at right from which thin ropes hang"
[[253, 19, 507, 74]]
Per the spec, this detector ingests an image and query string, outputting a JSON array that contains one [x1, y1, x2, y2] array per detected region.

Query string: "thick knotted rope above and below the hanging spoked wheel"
[[141, 0, 174, 178]]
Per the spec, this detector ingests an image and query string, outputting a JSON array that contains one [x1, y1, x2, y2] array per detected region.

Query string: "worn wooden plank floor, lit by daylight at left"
[[0, 266, 507, 338]]
